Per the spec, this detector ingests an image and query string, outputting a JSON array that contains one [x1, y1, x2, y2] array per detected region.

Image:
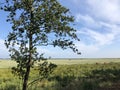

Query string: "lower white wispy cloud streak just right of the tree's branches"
[[78, 28, 116, 46]]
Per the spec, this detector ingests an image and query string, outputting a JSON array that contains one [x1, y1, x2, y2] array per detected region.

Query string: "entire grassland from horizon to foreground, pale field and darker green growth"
[[0, 59, 120, 90]]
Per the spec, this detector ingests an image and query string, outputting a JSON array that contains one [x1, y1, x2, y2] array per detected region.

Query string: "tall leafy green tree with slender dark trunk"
[[3, 0, 80, 90]]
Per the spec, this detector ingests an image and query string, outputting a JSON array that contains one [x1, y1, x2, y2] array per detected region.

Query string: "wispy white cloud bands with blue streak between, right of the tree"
[[76, 13, 120, 46]]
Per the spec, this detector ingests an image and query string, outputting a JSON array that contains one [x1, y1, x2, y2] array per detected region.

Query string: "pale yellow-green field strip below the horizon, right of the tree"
[[49, 58, 120, 65]]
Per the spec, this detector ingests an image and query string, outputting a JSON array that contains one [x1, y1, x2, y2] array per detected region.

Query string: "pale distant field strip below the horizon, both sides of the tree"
[[0, 58, 120, 68]]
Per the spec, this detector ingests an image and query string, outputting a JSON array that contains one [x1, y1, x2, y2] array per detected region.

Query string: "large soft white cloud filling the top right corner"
[[87, 0, 120, 24]]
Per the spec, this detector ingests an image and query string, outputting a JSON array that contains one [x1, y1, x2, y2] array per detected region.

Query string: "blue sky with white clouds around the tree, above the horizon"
[[0, 0, 120, 58]]
